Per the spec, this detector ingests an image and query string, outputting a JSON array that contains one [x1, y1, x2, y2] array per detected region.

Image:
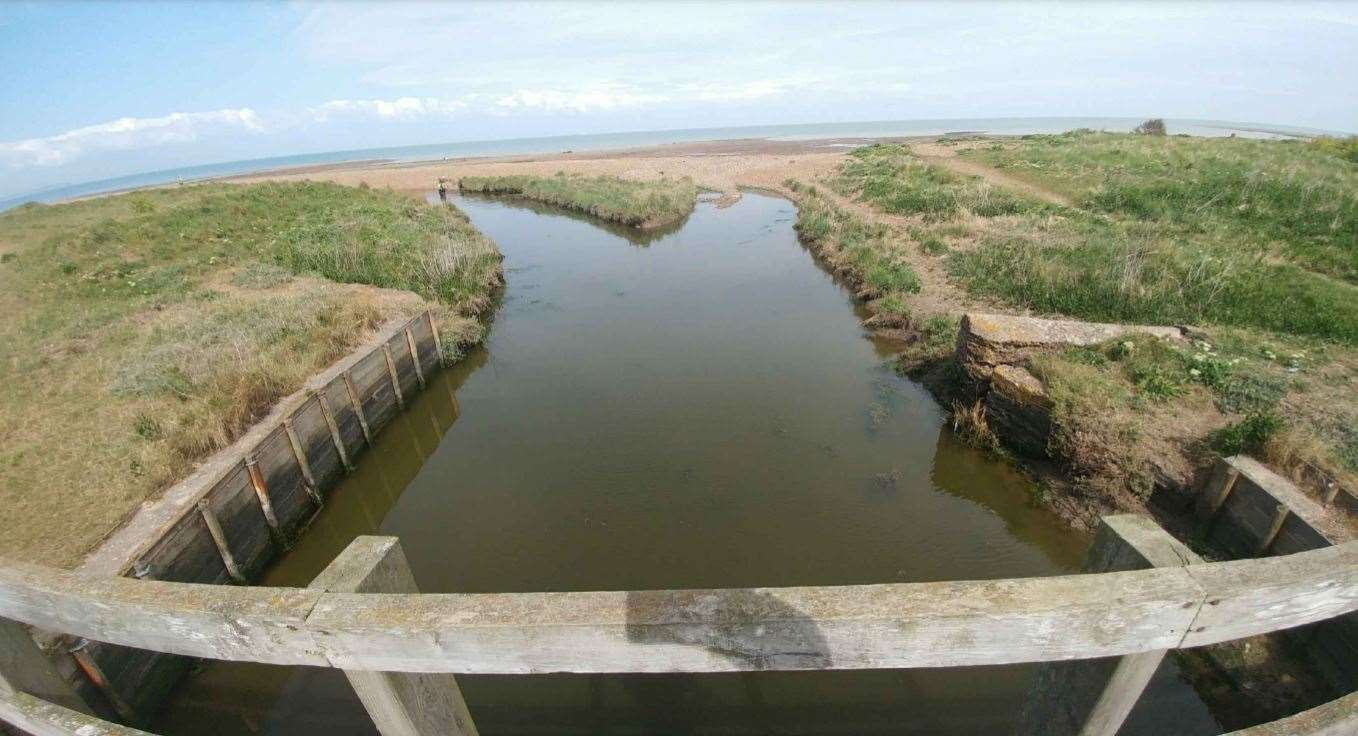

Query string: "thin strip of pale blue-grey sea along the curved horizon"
[[0, 117, 1343, 212]]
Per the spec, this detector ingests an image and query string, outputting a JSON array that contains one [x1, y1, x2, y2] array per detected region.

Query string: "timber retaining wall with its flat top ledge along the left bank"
[[49, 312, 443, 724]]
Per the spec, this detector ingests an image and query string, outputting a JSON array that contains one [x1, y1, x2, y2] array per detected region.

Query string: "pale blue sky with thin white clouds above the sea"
[[0, 0, 1358, 198]]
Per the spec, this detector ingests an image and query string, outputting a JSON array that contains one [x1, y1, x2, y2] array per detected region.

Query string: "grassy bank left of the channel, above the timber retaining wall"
[[0, 183, 500, 565]]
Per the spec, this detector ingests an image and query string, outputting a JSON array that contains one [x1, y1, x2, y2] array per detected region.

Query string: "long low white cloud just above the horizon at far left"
[[0, 107, 265, 168]]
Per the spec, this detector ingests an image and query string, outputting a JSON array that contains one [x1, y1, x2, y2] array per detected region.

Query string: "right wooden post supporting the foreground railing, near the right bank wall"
[[1017, 515, 1202, 736]]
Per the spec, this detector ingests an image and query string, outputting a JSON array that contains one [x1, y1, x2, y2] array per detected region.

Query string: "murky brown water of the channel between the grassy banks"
[[153, 194, 1215, 736]]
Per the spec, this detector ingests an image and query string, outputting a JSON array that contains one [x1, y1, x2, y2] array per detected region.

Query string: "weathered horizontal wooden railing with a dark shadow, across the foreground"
[[0, 526, 1358, 733]]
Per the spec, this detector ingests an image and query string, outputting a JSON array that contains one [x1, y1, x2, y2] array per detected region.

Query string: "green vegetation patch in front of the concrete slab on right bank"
[[1031, 329, 1358, 483]]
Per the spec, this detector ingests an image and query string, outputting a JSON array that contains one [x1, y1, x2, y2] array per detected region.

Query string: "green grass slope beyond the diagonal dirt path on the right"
[[967, 133, 1358, 284]]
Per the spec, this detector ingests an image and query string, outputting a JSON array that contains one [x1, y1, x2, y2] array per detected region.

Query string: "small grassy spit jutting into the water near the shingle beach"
[[458, 174, 698, 228]]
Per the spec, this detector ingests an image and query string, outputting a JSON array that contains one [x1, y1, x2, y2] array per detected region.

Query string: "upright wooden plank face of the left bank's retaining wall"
[[67, 312, 440, 724]]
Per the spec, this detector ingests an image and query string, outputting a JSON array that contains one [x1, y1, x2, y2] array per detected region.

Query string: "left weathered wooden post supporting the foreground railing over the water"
[[310, 536, 477, 736]]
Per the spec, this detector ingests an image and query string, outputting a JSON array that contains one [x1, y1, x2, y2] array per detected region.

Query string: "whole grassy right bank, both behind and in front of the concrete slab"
[[804, 132, 1358, 513]]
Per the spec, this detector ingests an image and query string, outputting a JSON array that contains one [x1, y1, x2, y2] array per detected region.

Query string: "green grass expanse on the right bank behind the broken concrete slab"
[[834, 132, 1358, 345]]
